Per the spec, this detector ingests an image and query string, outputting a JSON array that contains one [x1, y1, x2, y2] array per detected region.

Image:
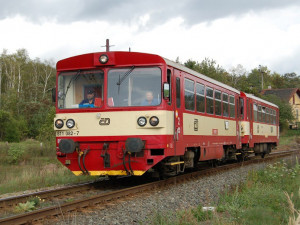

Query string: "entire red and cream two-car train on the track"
[[52, 51, 279, 177]]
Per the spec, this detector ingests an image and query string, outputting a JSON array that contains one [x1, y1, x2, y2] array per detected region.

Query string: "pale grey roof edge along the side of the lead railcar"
[[164, 58, 240, 94]]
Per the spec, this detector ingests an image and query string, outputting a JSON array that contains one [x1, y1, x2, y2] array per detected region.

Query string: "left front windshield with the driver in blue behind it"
[[58, 70, 104, 109]]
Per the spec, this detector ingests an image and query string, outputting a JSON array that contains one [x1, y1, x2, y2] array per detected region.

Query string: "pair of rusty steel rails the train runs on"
[[0, 150, 300, 225]]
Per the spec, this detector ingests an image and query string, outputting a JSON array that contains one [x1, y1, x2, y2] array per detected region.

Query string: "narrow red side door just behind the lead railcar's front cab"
[[173, 69, 184, 155]]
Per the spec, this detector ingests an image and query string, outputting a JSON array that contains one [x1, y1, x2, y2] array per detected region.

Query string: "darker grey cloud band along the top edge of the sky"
[[0, 0, 300, 26]]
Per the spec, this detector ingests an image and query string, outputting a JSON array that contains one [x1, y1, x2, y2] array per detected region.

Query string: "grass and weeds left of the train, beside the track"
[[0, 140, 95, 194]]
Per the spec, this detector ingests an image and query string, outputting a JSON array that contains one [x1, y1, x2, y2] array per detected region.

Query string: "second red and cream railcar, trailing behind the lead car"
[[240, 92, 279, 156]]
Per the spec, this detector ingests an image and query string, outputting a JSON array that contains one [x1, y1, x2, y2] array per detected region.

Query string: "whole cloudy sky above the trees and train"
[[0, 0, 300, 75]]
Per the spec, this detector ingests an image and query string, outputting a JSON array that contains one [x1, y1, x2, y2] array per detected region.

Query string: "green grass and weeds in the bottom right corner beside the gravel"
[[152, 159, 300, 225]]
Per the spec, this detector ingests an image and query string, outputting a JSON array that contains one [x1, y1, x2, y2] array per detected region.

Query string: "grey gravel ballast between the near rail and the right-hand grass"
[[51, 156, 295, 225]]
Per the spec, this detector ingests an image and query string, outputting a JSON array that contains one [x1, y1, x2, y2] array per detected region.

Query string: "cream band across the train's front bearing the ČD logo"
[[54, 110, 174, 137]]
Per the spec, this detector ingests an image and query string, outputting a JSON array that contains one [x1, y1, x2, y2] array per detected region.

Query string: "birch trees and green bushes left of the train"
[[0, 49, 55, 142]]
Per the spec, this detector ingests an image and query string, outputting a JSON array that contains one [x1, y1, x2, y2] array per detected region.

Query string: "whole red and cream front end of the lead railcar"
[[54, 52, 175, 176]]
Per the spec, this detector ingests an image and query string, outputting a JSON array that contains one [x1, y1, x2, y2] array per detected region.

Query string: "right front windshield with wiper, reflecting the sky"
[[107, 67, 161, 107]]
